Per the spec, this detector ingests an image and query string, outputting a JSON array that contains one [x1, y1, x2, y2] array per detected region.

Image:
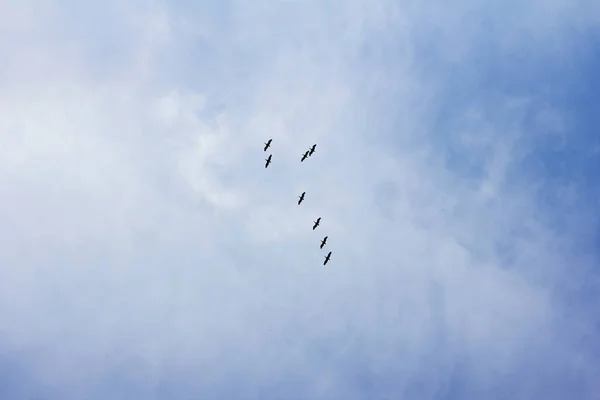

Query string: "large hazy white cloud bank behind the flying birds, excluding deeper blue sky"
[[0, 1, 593, 398]]
